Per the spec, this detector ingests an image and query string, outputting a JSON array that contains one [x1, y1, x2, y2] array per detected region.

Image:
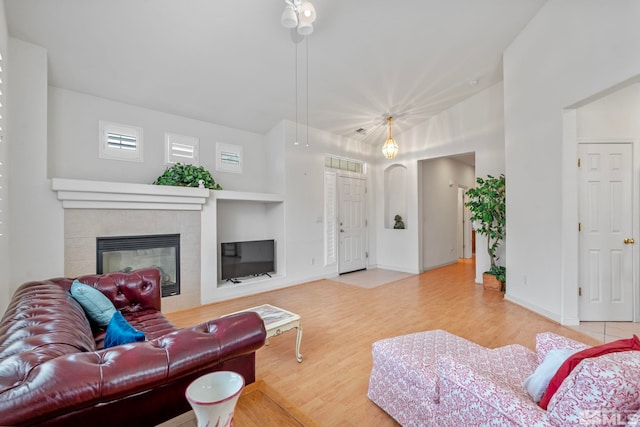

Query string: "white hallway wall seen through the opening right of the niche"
[[421, 157, 472, 270]]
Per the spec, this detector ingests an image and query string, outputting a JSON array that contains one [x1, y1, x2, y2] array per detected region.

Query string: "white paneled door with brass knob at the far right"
[[579, 143, 634, 321]]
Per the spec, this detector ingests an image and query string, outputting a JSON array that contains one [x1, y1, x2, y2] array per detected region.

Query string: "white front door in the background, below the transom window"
[[338, 176, 367, 274]]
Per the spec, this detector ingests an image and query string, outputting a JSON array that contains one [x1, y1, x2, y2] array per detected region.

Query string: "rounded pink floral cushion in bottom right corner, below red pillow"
[[547, 351, 640, 425]]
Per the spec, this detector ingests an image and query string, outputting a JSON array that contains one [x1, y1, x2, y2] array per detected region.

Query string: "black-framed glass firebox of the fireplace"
[[96, 234, 180, 297]]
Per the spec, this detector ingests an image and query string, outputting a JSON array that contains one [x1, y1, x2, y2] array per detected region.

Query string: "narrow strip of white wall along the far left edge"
[[0, 0, 12, 313]]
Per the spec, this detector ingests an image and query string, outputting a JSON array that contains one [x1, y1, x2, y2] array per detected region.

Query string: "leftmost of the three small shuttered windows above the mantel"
[[99, 120, 143, 162]]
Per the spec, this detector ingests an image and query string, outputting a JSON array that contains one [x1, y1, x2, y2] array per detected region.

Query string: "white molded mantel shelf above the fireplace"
[[51, 178, 211, 211]]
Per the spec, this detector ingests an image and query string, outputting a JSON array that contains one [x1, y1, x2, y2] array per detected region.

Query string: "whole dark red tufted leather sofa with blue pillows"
[[0, 269, 266, 427]]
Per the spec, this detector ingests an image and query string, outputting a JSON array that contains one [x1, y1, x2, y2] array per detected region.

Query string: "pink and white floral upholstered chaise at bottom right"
[[367, 330, 640, 427]]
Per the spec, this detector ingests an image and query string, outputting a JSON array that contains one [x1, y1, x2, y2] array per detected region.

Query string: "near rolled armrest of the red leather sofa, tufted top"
[[0, 312, 266, 425]]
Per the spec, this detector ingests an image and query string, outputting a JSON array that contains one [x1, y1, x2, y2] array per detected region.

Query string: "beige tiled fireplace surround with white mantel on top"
[[52, 179, 209, 312]]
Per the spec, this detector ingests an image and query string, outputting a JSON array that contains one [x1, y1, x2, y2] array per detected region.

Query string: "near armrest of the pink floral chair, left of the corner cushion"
[[437, 356, 549, 426]]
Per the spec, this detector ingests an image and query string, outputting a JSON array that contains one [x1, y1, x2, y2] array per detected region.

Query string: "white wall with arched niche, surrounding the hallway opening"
[[375, 84, 504, 282]]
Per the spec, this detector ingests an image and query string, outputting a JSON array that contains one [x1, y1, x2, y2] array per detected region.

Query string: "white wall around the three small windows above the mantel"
[[48, 87, 270, 191]]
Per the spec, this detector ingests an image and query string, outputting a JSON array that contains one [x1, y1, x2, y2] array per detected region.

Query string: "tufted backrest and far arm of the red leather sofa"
[[0, 269, 164, 404]]
